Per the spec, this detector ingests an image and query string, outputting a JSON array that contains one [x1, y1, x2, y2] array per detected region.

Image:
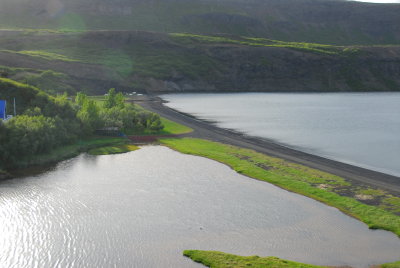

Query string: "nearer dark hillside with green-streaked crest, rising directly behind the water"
[[0, 31, 400, 93]]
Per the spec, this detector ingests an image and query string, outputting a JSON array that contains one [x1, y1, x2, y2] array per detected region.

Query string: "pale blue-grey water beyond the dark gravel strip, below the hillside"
[[163, 93, 400, 176]]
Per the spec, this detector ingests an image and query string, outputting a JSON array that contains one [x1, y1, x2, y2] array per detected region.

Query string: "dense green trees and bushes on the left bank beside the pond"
[[0, 81, 163, 169]]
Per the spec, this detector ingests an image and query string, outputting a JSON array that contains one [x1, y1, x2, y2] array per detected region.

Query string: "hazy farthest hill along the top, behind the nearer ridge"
[[0, 0, 400, 45]]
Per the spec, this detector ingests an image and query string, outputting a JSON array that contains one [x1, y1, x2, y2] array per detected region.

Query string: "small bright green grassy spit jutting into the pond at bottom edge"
[[183, 250, 325, 268]]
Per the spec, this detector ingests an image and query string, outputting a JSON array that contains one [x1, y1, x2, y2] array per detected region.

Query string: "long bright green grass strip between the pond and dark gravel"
[[160, 138, 400, 236]]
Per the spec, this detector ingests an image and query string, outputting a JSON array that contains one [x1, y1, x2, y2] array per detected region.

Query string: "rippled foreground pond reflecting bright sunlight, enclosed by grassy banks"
[[0, 146, 400, 268]]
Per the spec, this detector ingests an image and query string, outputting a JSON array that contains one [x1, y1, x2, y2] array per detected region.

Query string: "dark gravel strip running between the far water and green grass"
[[132, 97, 400, 196]]
